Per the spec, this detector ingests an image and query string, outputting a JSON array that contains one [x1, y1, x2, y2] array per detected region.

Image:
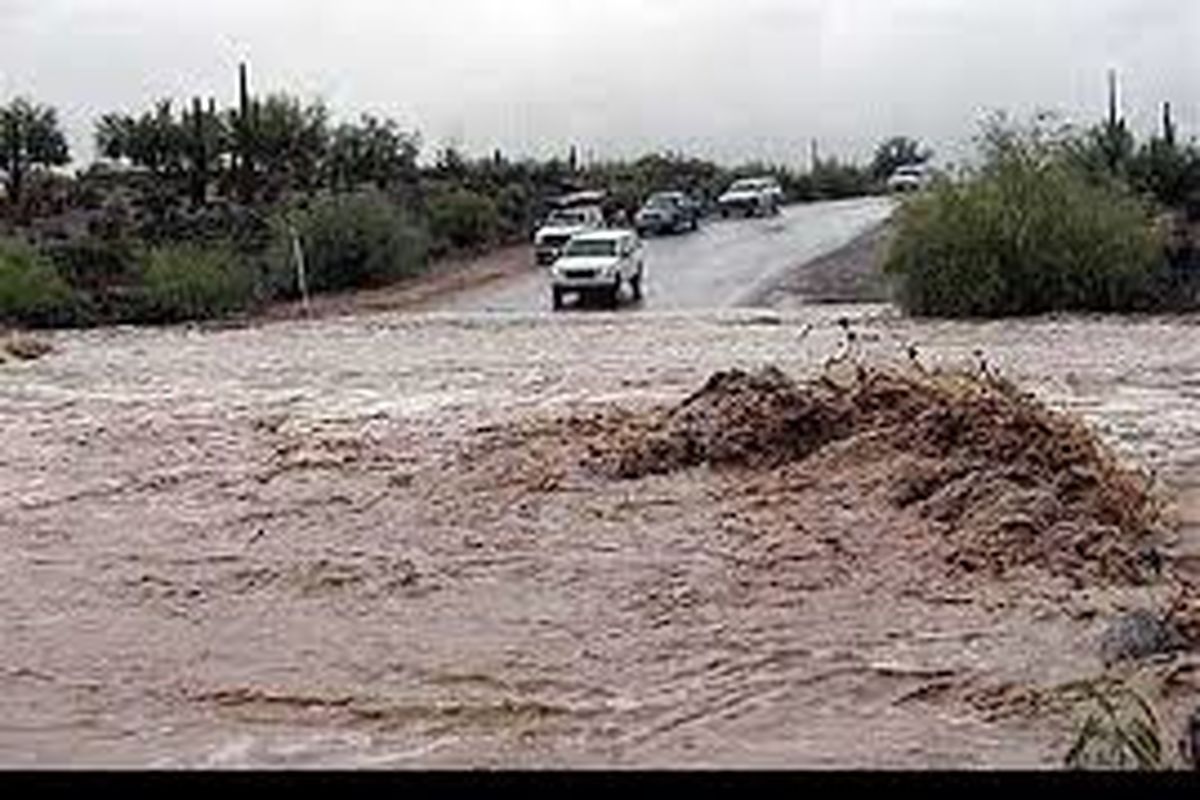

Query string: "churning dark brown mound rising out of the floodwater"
[[592, 366, 1162, 583]]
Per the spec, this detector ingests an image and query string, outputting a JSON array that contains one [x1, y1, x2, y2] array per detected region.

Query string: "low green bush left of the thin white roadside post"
[[136, 245, 253, 323]]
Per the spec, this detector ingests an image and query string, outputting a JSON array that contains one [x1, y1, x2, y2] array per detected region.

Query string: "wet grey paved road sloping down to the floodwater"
[[439, 198, 895, 312]]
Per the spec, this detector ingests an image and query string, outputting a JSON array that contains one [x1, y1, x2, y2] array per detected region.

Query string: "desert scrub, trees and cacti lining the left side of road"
[[0, 65, 882, 327]]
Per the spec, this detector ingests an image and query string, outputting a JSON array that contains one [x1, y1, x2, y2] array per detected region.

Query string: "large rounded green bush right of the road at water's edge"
[[884, 128, 1164, 317]]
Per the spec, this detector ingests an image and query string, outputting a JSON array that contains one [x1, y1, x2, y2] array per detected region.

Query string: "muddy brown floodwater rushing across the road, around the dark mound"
[[7, 306, 1200, 768]]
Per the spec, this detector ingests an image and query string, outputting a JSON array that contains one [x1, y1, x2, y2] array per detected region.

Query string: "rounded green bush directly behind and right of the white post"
[[291, 192, 428, 295]]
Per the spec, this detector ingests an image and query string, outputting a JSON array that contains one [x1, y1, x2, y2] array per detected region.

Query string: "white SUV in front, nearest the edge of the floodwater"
[[550, 230, 646, 311]]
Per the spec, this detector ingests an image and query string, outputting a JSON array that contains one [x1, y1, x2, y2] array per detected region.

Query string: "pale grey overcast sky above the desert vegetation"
[[0, 0, 1200, 164]]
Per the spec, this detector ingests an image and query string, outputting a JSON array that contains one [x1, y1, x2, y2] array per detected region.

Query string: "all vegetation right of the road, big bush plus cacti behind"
[[884, 81, 1200, 318]]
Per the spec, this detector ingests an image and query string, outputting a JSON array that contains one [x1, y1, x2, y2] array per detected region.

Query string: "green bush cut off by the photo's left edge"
[[0, 240, 77, 327]]
